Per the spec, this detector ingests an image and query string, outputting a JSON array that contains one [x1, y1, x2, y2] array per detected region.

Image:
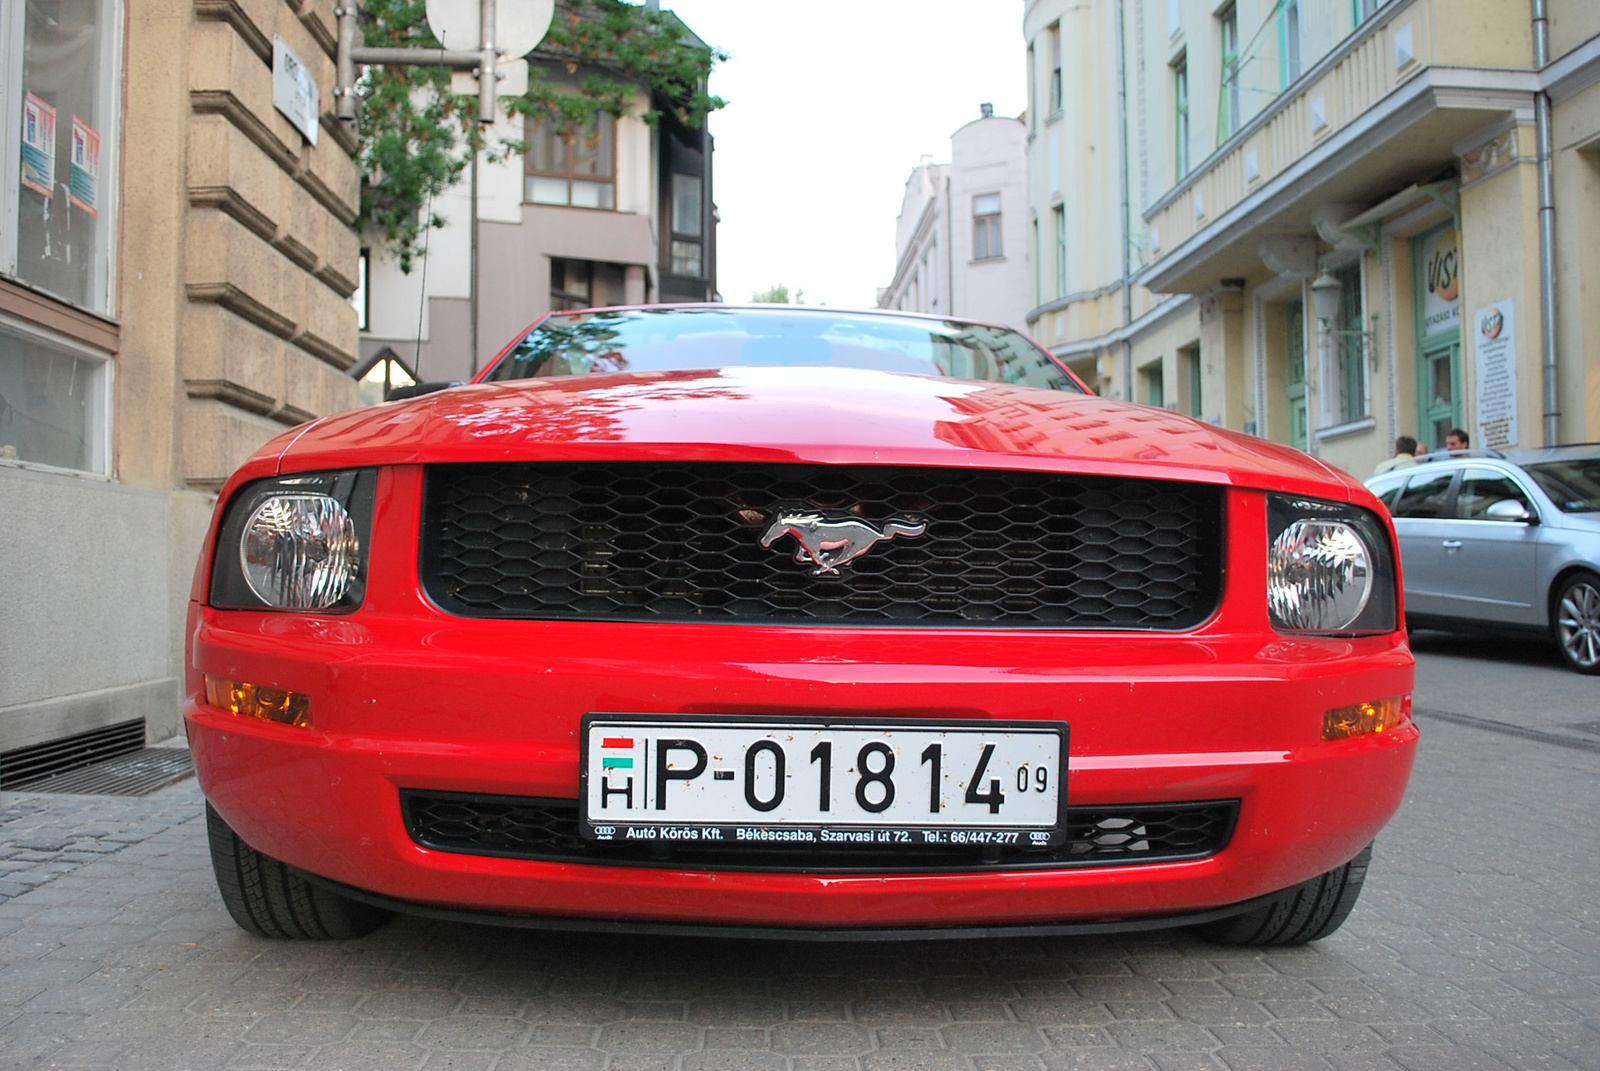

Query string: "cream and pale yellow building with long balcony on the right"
[[1024, 0, 1600, 475]]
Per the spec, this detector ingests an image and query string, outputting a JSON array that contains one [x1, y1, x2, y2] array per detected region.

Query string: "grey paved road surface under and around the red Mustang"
[[0, 636, 1600, 1071]]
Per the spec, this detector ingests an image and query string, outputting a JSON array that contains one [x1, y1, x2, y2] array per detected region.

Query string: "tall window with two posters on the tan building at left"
[[0, 0, 123, 315]]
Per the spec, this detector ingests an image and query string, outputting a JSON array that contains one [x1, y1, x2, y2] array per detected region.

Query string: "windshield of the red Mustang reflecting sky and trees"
[[485, 307, 1080, 391]]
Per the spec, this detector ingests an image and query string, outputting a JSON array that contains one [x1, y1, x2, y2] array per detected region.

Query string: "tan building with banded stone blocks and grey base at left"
[[0, 0, 360, 768]]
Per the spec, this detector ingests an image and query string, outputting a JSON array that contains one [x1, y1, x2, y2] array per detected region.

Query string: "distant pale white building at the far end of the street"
[[878, 104, 1032, 328]]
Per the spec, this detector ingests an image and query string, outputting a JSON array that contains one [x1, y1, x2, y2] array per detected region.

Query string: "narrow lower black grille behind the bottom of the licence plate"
[[400, 789, 1238, 874]]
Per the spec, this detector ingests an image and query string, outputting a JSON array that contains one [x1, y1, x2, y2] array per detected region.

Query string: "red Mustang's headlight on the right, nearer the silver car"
[[1267, 495, 1397, 634]]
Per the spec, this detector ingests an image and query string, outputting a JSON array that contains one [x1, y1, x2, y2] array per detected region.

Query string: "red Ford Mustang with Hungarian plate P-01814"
[[186, 306, 1418, 945]]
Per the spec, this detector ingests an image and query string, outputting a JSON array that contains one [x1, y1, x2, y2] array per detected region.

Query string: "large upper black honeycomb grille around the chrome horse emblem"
[[421, 463, 1222, 631]]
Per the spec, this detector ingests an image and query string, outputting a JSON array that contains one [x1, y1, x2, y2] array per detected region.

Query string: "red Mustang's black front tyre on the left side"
[[205, 804, 389, 941]]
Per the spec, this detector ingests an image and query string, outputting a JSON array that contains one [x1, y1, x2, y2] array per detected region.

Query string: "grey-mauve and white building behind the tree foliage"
[[363, 38, 717, 389]]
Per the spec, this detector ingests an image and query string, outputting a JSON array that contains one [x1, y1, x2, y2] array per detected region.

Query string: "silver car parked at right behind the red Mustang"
[[1366, 443, 1600, 674]]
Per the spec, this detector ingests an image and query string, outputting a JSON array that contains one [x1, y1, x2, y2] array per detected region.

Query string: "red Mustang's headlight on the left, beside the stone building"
[[210, 469, 376, 612]]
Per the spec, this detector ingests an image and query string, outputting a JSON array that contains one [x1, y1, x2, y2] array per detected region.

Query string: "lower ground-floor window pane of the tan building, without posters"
[[0, 319, 110, 474]]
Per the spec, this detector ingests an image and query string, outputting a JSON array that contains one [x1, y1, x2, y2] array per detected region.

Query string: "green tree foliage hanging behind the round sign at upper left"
[[357, 0, 726, 272]]
